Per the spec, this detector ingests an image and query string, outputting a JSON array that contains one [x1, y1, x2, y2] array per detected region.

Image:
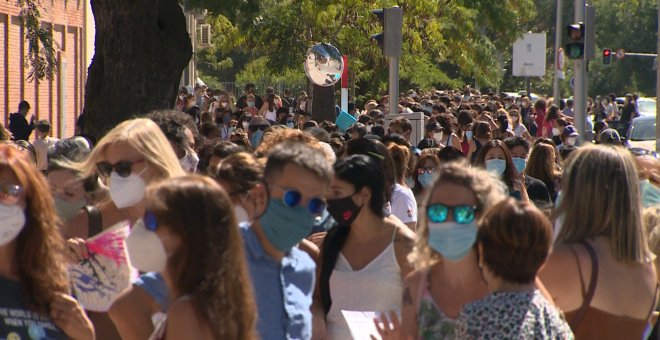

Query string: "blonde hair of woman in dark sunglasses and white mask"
[[82, 118, 186, 180]]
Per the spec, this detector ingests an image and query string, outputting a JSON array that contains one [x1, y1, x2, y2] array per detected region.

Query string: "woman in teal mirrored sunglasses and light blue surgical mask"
[[374, 162, 506, 339]]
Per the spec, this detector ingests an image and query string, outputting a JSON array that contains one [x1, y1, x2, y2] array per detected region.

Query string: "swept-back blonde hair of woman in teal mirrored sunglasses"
[[408, 160, 507, 268]]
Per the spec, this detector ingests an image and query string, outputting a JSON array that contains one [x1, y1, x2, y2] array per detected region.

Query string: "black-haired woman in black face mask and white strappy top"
[[313, 155, 415, 339]]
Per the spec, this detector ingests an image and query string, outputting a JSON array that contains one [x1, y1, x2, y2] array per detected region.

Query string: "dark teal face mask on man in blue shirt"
[[259, 198, 314, 252]]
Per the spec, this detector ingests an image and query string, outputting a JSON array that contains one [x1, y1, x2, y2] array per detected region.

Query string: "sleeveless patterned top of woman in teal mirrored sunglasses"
[[416, 268, 462, 340]]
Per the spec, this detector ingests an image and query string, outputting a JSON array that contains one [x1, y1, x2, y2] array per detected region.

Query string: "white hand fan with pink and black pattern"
[[69, 221, 138, 312]]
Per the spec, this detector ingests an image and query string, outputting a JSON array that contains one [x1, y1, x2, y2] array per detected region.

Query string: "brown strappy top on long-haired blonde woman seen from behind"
[[566, 241, 658, 340]]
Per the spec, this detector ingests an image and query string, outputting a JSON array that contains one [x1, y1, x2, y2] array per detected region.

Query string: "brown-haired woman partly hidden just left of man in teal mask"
[[210, 152, 264, 223]]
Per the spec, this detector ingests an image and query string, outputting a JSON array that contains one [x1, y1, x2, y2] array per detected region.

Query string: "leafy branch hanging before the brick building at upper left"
[[16, 0, 59, 80]]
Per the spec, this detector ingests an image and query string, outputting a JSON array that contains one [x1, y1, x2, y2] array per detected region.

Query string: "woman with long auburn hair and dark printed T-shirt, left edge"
[[0, 145, 94, 339]]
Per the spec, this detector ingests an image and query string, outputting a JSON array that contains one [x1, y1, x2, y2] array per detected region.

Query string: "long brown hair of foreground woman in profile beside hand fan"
[[146, 175, 256, 339]]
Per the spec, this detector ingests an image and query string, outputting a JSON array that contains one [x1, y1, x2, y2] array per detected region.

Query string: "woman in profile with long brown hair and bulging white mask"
[[126, 176, 256, 339]]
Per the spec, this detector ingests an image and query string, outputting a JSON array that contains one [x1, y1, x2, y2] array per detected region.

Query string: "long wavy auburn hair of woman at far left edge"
[[0, 144, 69, 314]]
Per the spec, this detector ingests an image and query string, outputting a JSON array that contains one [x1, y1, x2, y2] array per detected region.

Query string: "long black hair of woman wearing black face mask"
[[319, 155, 387, 314]]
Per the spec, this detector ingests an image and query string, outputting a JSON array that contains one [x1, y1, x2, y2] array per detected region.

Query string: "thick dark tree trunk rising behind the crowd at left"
[[82, 0, 192, 138]]
